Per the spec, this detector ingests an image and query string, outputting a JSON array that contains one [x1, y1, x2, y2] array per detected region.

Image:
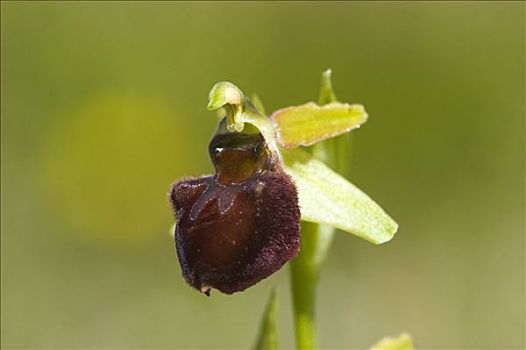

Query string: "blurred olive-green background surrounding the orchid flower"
[[1, 2, 526, 349]]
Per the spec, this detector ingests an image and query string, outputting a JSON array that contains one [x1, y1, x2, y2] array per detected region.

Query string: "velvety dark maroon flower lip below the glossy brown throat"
[[171, 168, 299, 294]]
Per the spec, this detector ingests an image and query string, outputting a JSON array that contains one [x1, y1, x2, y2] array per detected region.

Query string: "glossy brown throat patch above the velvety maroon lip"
[[209, 133, 271, 185]]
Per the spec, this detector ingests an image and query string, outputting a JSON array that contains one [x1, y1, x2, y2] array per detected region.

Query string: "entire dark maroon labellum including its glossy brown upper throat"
[[170, 127, 300, 294]]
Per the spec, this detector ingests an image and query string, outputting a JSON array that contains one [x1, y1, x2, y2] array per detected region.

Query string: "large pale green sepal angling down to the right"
[[282, 148, 398, 244]]
